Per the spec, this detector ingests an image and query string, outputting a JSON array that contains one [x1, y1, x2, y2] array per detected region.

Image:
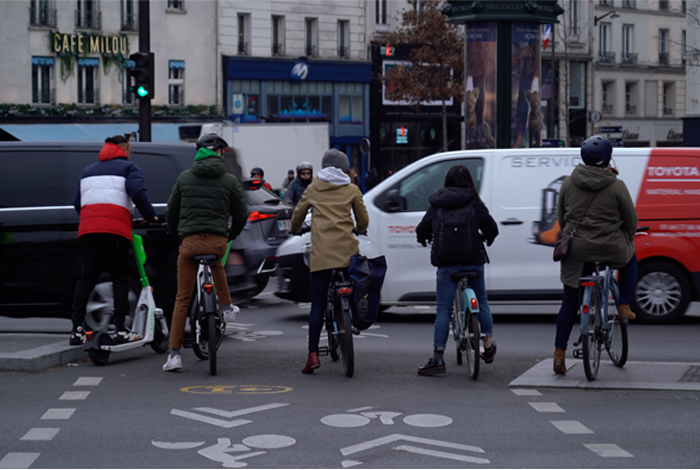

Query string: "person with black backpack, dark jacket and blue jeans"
[[416, 165, 498, 375]]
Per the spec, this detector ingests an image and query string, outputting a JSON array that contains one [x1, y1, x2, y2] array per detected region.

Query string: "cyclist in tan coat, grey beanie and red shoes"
[[291, 149, 369, 374]]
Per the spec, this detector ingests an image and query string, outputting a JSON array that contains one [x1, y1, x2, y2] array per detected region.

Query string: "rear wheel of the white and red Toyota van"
[[630, 262, 691, 324]]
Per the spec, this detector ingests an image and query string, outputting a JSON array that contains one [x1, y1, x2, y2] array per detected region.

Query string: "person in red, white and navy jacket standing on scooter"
[[68, 135, 158, 345]]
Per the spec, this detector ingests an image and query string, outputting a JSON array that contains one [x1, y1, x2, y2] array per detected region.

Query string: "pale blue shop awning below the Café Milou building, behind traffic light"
[[0, 122, 191, 143]]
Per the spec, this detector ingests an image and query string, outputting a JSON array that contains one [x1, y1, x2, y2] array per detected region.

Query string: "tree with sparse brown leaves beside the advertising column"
[[379, 0, 464, 150]]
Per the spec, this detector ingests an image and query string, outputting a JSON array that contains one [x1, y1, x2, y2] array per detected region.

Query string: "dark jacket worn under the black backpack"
[[416, 187, 498, 267]]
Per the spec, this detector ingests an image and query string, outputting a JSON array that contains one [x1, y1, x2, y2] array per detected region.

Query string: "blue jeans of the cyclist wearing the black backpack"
[[433, 264, 493, 351]]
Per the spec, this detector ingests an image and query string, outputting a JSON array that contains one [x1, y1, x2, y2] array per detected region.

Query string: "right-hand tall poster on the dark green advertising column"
[[511, 21, 542, 148]]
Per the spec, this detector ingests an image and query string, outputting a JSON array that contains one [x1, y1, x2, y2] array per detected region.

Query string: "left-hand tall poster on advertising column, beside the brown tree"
[[464, 21, 497, 149]]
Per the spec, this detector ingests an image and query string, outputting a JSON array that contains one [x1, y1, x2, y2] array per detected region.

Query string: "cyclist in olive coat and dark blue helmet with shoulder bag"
[[554, 135, 637, 374]]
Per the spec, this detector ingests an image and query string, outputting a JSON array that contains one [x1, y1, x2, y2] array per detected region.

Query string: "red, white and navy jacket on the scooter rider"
[[73, 143, 156, 240]]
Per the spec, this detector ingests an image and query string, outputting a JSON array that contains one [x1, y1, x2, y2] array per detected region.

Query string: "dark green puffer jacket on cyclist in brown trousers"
[[166, 148, 248, 239]]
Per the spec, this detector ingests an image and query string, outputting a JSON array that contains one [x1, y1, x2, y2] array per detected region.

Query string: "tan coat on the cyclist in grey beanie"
[[291, 177, 369, 272]]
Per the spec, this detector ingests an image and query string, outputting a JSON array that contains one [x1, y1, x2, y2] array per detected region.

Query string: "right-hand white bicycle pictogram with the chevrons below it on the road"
[[321, 406, 490, 468]]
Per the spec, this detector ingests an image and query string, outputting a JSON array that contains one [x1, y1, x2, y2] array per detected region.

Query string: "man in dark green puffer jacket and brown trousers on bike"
[[163, 134, 248, 371]]
